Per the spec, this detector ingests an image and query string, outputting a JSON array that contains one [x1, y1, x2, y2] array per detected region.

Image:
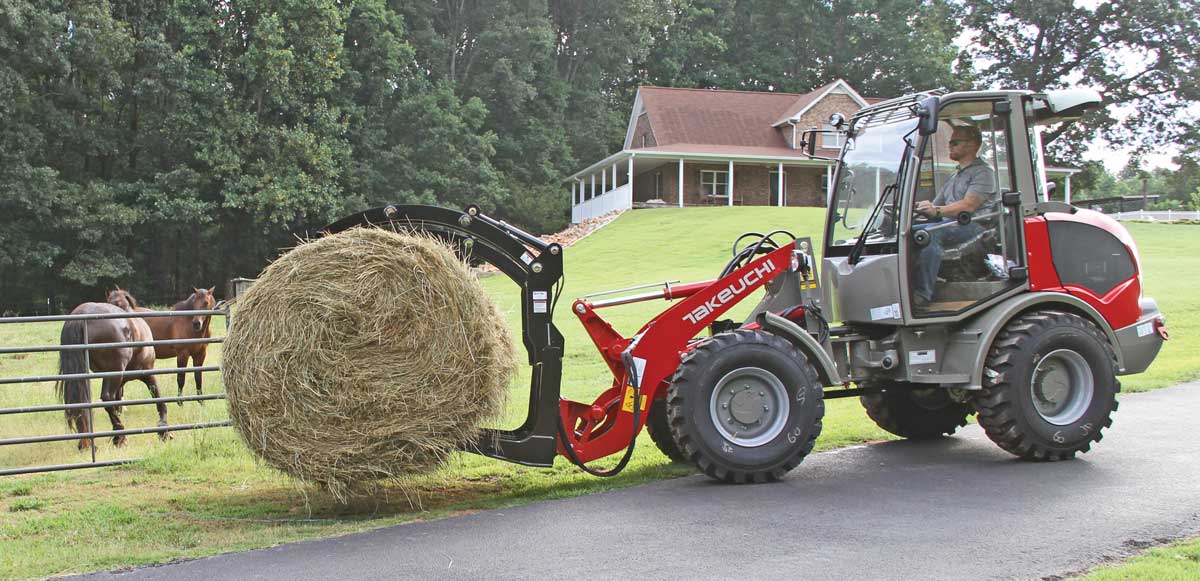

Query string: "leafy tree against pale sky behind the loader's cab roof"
[[964, 0, 1200, 163]]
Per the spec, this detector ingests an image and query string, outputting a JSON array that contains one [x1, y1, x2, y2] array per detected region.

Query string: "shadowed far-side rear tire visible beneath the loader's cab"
[[858, 382, 974, 439]]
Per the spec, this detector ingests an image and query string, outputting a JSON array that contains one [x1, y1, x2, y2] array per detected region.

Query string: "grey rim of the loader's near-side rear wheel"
[[1030, 349, 1096, 426]]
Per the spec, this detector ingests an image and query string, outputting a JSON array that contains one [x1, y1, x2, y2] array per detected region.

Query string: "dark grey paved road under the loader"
[[84, 383, 1200, 581]]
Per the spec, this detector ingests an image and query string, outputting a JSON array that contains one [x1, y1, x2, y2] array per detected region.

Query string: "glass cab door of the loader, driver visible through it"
[[900, 97, 1025, 322]]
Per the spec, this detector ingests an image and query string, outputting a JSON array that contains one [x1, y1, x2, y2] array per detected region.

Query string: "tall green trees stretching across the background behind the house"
[[0, 0, 1200, 312]]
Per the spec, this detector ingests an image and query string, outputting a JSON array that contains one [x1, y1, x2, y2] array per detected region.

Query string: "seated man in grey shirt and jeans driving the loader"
[[912, 125, 996, 310]]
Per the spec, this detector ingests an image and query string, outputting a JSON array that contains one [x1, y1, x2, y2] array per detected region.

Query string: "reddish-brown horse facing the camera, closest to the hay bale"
[[108, 287, 216, 406]]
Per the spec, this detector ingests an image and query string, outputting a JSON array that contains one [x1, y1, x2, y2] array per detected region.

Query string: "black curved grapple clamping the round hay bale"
[[322, 205, 563, 467]]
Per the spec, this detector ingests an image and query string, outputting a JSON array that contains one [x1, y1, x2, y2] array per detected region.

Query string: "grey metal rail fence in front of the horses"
[[0, 304, 230, 477]]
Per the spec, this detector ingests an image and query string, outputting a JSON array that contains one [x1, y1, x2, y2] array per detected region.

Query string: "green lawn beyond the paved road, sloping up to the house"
[[0, 208, 1200, 577]]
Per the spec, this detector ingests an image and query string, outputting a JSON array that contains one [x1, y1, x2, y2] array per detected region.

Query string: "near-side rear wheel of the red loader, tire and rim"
[[973, 311, 1121, 461]]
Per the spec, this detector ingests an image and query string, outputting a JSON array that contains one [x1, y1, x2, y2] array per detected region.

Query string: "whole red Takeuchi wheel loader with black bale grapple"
[[326, 90, 1168, 483]]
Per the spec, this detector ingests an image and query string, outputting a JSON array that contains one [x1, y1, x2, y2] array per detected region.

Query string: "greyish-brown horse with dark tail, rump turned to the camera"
[[55, 303, 170, 450]]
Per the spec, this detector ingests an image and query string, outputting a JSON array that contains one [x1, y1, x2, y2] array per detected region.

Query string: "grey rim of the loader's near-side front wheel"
[[708, 367, 788, 448]]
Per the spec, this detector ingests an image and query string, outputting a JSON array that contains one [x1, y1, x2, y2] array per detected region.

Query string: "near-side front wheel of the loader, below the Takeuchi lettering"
[[666, 330, 824, 484]]
